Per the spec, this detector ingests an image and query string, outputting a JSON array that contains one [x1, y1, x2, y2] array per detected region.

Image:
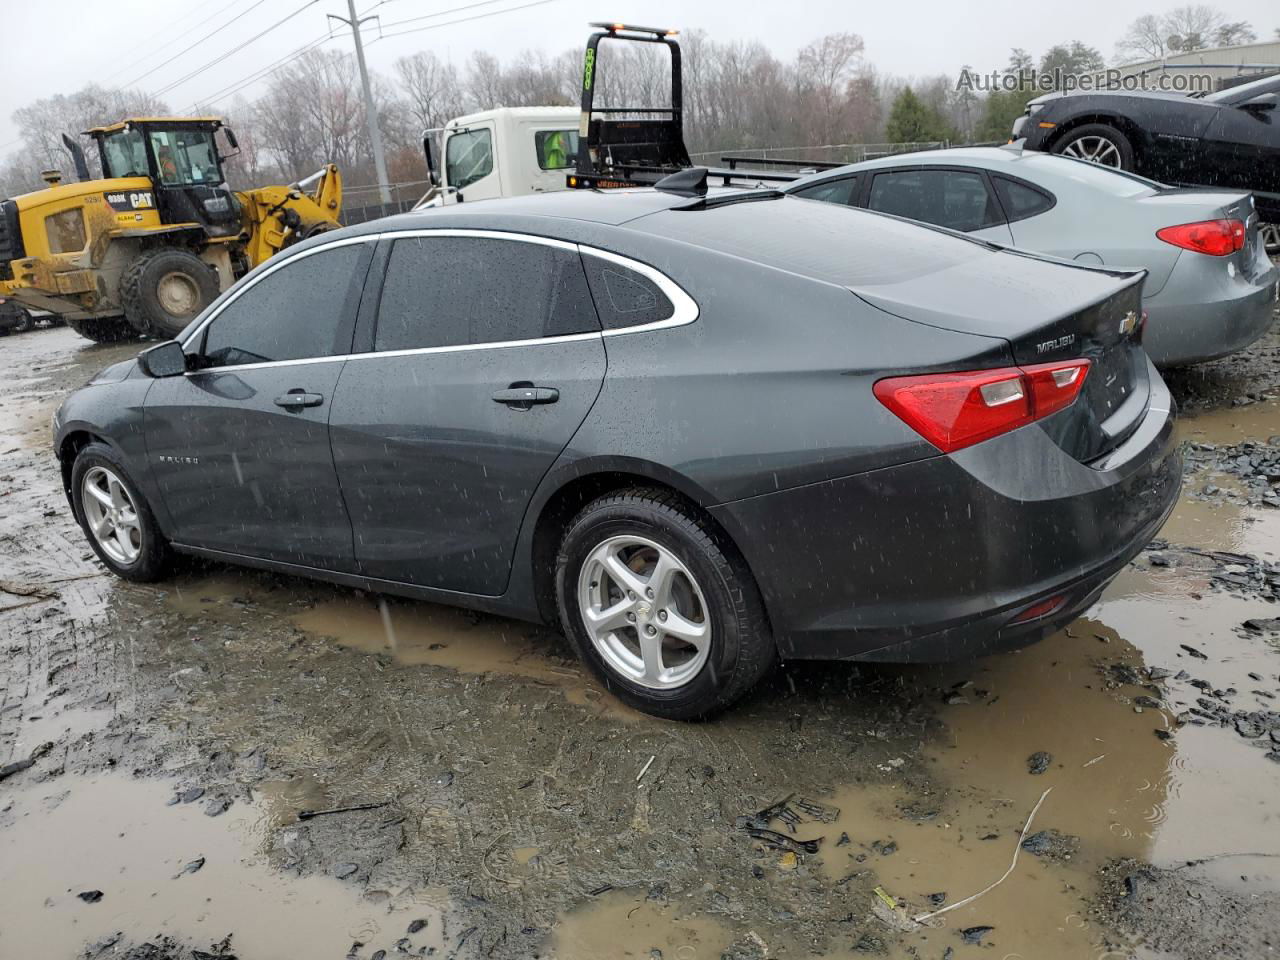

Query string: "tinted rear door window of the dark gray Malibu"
[[374, 237, 600, 351]]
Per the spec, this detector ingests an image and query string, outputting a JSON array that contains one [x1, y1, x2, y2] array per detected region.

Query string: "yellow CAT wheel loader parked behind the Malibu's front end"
[[0, 116, 342, 342]]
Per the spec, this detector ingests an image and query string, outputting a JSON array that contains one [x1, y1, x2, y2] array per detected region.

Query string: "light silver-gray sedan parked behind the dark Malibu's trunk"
[[787, 147, 1280, 367]]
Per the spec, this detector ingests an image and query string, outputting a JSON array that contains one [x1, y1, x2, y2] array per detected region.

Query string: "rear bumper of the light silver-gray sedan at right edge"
[[1142, 255, 1280, 367]]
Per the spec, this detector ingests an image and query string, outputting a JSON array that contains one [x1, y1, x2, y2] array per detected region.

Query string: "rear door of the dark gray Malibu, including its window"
[[330, 230, 605, 596]]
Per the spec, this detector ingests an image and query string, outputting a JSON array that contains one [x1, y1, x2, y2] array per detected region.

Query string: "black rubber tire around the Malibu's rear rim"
[[556, 489, 777, 719]]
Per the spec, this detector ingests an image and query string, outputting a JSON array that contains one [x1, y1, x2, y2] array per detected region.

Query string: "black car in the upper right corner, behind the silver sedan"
[[1014, 77, 1280, 246]]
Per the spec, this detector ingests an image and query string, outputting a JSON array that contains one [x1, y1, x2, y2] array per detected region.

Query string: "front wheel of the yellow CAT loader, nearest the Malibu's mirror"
[[120, 247, 219, 338]]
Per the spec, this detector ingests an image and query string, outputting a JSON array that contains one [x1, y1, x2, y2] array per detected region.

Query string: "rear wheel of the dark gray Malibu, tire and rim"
[[556, 489, 777, 719]]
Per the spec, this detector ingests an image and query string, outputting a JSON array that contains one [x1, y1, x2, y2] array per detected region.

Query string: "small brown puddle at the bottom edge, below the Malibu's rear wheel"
[[547, 890, 733, 960]]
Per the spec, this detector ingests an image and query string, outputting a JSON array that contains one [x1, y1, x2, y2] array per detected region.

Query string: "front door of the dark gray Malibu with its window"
[[145, 239, 374, 571]]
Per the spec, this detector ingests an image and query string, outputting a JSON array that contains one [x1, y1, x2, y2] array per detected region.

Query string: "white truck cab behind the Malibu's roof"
[[415, 106, 581, 210]]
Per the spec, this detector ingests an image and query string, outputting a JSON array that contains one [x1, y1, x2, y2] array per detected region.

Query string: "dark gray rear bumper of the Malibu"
[[713, 360, 1181, 660]]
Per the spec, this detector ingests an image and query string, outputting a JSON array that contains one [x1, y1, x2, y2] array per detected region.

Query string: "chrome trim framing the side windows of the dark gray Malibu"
[[182, 228, 699, 376]]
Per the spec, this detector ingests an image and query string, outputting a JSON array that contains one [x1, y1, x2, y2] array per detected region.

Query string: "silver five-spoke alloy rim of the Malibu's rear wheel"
[[577, 535, 712, 690]]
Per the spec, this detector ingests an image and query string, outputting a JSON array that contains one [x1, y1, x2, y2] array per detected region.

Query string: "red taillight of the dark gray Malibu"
[[874, 360, 1089, 453]]
